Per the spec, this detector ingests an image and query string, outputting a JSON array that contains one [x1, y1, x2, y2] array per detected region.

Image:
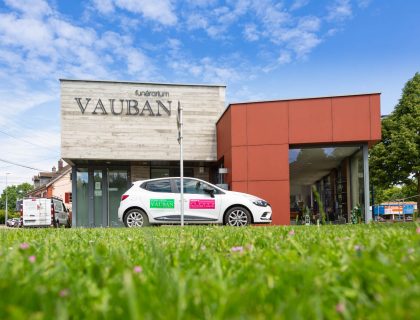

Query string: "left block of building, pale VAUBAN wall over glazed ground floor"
[[61, 80, 225, 227]]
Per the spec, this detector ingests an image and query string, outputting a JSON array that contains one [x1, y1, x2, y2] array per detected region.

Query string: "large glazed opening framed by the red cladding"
[[289, 145, 365, 223]]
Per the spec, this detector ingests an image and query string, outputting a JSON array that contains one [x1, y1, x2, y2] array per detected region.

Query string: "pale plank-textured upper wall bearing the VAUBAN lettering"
[[61, 80, 225, 161]]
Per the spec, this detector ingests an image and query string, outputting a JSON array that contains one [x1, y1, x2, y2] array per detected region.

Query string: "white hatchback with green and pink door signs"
[[118, 178, 271, 228]]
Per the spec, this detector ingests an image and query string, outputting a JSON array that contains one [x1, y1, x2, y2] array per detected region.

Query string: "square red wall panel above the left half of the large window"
[[289, 98, 332, 144]]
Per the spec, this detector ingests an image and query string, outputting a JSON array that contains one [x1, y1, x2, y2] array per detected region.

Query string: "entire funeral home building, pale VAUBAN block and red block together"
[[61, 80, 381, 227]]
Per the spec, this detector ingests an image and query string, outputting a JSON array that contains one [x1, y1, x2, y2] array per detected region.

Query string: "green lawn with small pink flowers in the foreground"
[[0, 223, 420, 319]]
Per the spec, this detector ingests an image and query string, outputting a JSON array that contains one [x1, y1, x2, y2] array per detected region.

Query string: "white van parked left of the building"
[[21, 198, 71, 227]]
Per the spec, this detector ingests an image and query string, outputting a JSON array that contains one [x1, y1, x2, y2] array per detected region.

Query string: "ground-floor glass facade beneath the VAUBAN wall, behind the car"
[[73, 162, 216, 227]]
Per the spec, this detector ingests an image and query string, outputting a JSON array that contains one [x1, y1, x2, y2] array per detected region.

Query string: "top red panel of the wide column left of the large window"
[[246, 102, 289, 145]]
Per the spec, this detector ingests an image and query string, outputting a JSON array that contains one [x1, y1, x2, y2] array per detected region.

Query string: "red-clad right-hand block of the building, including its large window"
[[217, 93, 381, 224]]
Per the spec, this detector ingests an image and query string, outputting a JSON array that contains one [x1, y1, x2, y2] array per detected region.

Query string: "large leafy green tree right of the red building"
[[369, 72, 420, 208]]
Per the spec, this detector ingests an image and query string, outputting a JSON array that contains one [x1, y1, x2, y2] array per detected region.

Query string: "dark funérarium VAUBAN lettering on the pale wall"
[[74, 90, 172, 117]]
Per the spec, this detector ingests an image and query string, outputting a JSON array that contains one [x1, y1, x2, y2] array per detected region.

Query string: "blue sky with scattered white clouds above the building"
[[0, 0, 420, 192]]
